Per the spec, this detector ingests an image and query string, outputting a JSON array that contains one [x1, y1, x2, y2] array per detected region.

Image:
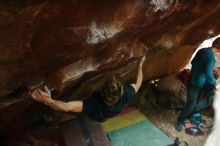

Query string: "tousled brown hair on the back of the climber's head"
[[102, 74, 123, 104]]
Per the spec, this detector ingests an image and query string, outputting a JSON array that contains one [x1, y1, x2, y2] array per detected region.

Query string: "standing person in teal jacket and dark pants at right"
[[175, 37, 220, 131]]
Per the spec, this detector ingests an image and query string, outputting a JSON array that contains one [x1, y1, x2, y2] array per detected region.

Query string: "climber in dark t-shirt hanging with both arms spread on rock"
[[31, 56, 145, 122]]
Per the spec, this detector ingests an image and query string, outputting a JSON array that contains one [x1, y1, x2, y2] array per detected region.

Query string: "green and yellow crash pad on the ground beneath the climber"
[[103, 110, 173, 146]]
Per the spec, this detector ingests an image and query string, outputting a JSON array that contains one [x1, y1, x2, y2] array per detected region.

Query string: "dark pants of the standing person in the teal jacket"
[[177, 85, 214, 123]]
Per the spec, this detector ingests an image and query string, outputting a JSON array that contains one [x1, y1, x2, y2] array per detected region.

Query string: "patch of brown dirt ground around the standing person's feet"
[[142, 108, 213, 146]]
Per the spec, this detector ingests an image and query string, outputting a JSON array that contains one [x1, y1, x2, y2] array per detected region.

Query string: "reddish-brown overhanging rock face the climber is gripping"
[[0, 0, 220, 136]]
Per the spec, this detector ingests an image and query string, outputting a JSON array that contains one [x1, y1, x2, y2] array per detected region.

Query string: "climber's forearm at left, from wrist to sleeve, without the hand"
[[45, 99, 82, 112]]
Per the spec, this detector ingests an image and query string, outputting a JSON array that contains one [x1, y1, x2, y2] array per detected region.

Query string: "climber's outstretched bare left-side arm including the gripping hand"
[[31, 88, 83, 113]]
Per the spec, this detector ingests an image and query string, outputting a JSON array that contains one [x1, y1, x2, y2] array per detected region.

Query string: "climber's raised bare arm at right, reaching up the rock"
[[131, 56, 146, 92]]
